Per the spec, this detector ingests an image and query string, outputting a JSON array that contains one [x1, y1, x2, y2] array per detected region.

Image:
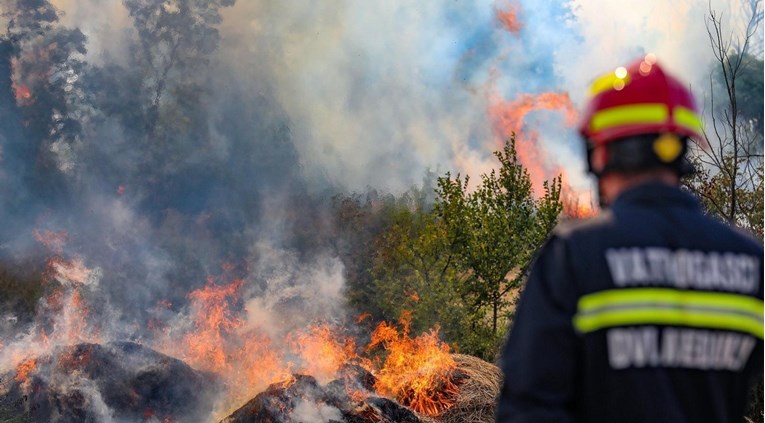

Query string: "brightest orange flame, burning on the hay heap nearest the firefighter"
[[367, 313, 459, 416]]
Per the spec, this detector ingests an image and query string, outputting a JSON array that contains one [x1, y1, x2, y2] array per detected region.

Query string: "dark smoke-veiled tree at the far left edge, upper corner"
[[0, 0, 86, 213]]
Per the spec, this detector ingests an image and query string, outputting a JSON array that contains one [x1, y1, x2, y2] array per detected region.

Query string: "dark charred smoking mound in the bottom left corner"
[[0, 342, 220, 423]]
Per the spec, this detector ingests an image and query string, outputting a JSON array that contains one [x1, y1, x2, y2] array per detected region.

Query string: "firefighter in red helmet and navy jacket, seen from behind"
[[497, 55, 763, 423]]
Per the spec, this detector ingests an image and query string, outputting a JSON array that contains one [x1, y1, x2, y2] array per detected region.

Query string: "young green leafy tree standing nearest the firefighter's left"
[[435, 136, 563, 356]]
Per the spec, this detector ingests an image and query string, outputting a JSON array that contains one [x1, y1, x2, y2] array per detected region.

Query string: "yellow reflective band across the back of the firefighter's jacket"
[[573, 288, 763, 339]]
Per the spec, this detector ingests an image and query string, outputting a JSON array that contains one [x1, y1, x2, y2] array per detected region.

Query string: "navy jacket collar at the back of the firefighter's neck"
[[611, 182, 701, 210]]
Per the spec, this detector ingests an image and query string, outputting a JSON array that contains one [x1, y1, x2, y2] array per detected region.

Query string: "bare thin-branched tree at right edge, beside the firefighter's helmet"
[[685, 1, 763, 237]]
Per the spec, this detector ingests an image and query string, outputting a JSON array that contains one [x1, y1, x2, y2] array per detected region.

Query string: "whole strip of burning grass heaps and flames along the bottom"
[[0, 253, 498, 423]]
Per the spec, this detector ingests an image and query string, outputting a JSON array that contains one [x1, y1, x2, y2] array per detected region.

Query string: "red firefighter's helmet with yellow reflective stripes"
[[579, 54, 704, 147]]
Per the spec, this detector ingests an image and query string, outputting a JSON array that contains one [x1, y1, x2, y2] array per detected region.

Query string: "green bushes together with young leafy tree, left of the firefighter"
[[346, 138, 562, 360]]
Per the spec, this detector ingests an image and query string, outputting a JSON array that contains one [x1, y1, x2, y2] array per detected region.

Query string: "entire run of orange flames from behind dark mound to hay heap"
[[148, 278, 458, 415]]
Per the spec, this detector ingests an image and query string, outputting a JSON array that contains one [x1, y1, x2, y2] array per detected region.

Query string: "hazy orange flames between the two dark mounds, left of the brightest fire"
[[155, 277, 356, 412]]
